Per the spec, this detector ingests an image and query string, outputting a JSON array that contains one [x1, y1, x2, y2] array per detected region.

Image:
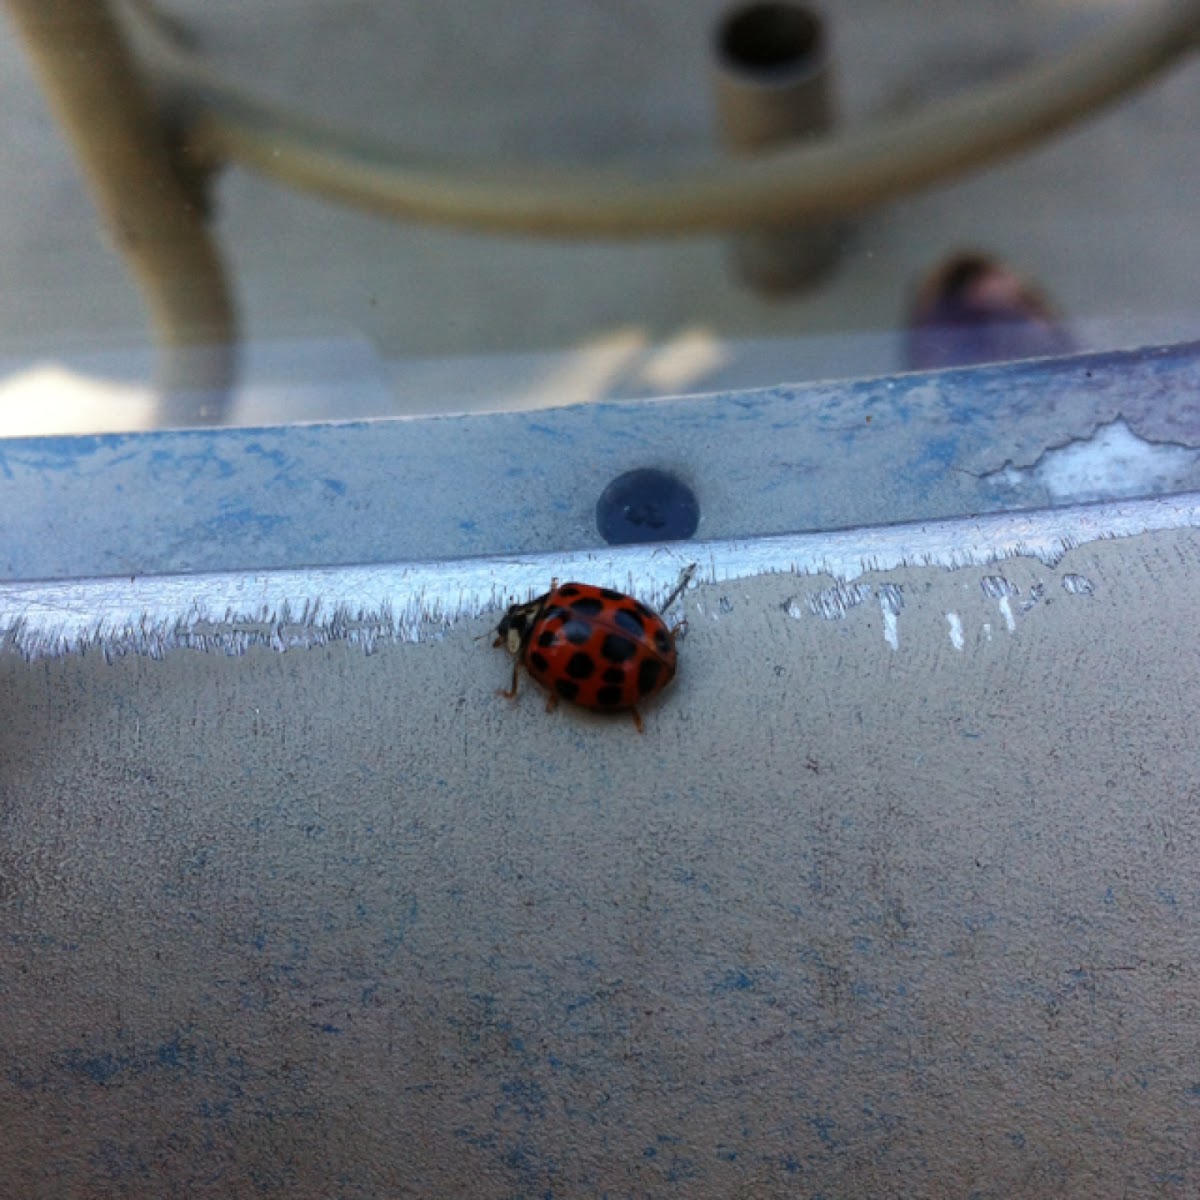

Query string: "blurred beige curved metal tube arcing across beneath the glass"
[[129, 0, 1200, 236]]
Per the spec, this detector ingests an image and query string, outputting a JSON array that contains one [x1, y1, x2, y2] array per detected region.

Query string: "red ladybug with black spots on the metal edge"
[[493, 583, 676, 731]]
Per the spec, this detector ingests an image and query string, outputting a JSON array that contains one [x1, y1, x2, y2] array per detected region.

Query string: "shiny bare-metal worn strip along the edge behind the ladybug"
[[0, 492, 1200, 659]]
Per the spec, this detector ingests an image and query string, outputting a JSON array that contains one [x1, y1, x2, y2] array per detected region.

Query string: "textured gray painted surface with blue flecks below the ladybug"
[[0, 520, 1200, 1200]]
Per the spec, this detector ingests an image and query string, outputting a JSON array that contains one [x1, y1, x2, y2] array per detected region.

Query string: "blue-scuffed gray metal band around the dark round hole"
[[0, 346, 1200, 580]]
